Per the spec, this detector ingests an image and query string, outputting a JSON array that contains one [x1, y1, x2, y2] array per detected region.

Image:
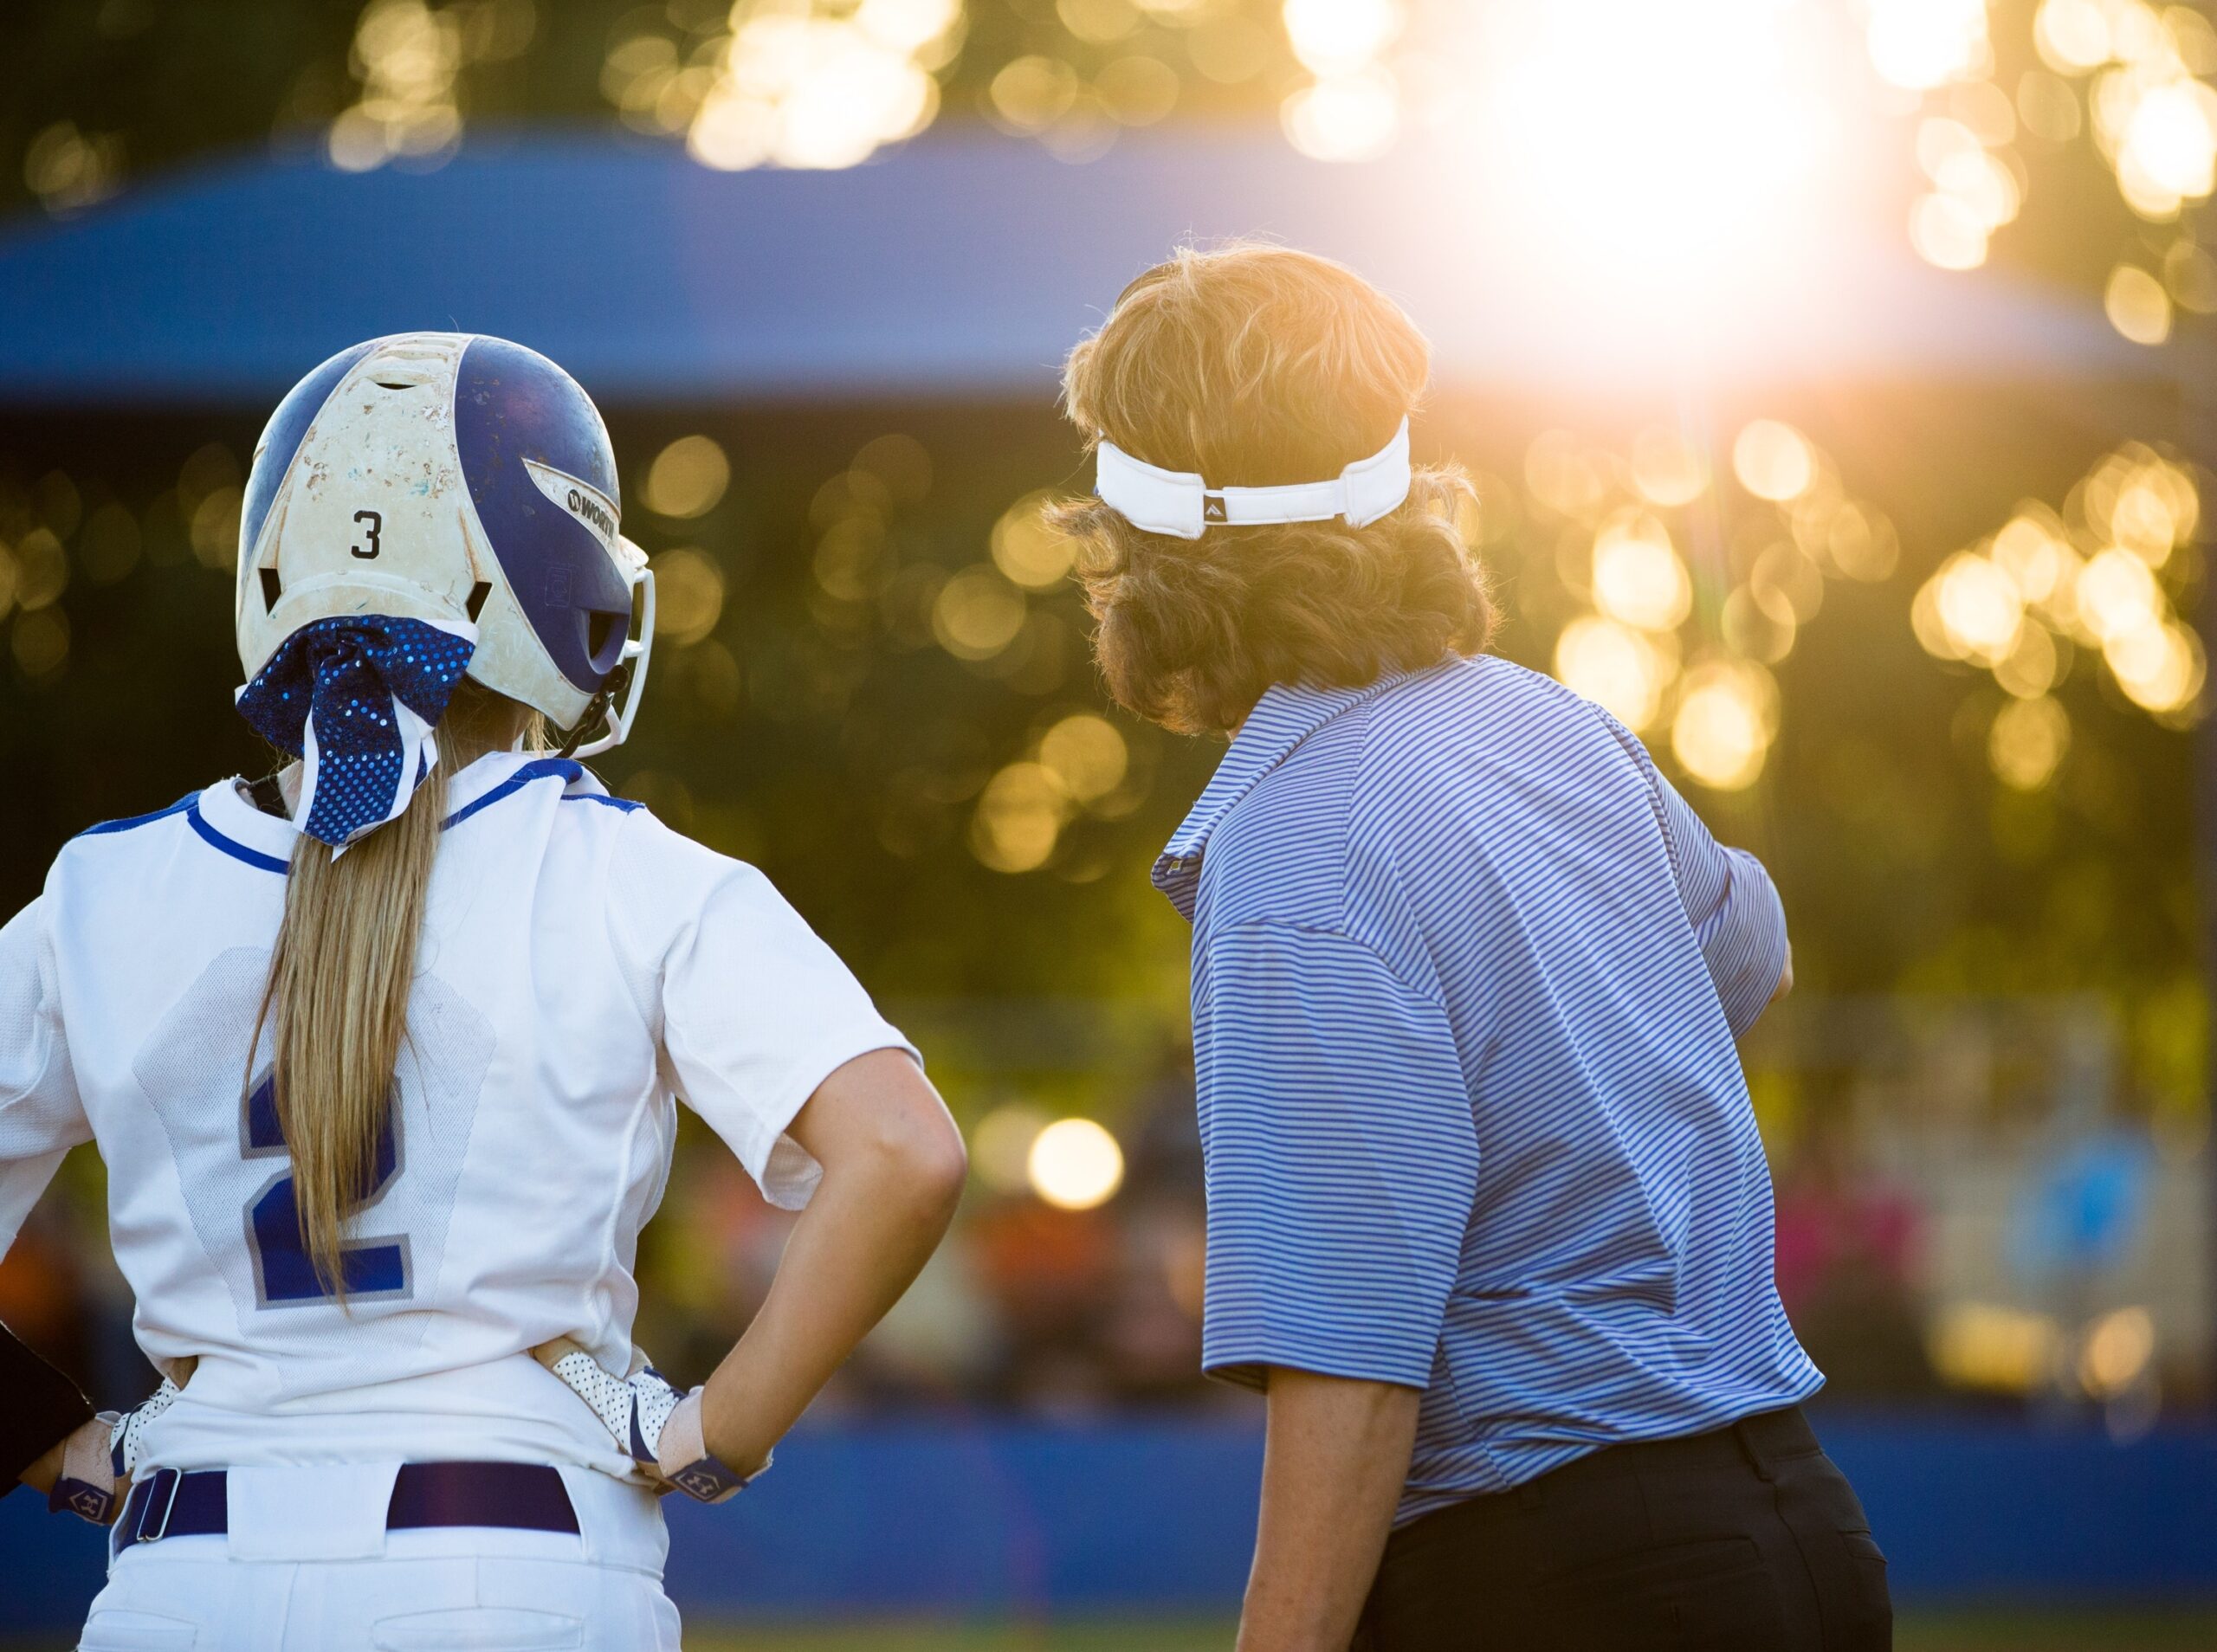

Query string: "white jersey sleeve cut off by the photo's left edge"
[[0, 896, 94, 1255]]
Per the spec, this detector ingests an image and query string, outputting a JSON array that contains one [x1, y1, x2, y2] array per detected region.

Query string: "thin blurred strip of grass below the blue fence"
[[685, 1608, 2217, 1652]]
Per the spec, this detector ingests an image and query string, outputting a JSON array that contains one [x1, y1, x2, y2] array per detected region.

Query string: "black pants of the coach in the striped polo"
[[1353, 1408, 1893, 1652]]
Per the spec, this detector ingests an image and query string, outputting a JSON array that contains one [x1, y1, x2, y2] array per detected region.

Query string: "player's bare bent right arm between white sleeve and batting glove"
[[701, 1054, 965, 1473]]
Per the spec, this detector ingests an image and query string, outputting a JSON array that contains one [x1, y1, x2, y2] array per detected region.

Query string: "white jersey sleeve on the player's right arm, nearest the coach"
[[610, 810, 922, 1210]]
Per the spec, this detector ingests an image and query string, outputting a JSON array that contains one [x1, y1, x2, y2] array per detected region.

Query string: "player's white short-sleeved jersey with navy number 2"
[[0, 754, 914, 1475]]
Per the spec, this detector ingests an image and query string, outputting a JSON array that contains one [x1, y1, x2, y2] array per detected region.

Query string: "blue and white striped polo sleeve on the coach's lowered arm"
[[1193, 922, 1479, 1388]]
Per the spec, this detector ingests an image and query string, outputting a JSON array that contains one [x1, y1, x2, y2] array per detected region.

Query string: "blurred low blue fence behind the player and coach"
[[0, 1417, 2217, 1632]]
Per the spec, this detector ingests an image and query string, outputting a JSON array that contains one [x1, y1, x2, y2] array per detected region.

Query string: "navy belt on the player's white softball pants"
[[108, 1463, 577, 1552]]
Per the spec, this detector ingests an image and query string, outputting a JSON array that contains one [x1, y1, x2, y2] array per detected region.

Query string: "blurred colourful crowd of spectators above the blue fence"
[[13, 1042, 2193, 1430]]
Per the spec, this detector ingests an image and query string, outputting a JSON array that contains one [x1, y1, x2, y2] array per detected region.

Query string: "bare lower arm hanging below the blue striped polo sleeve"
[[1239, 1368, 1419, 1652]]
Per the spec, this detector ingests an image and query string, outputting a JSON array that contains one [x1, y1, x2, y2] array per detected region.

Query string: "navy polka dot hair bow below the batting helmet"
[[239, 614, 476, 849]]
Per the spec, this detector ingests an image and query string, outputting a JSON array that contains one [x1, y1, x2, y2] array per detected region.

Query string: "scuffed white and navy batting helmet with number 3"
[[237, 332, 654, 756]]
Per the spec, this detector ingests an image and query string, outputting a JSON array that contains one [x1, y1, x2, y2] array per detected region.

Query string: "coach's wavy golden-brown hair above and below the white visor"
[[1053, 242, 1494, 732]]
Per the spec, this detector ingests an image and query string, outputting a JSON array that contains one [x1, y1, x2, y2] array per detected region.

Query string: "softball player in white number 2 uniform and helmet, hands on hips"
[[0, 332, 962, 1652]]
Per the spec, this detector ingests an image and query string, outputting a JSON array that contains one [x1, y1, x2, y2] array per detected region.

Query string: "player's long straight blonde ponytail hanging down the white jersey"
[[246, 679, 539, 1301]]
